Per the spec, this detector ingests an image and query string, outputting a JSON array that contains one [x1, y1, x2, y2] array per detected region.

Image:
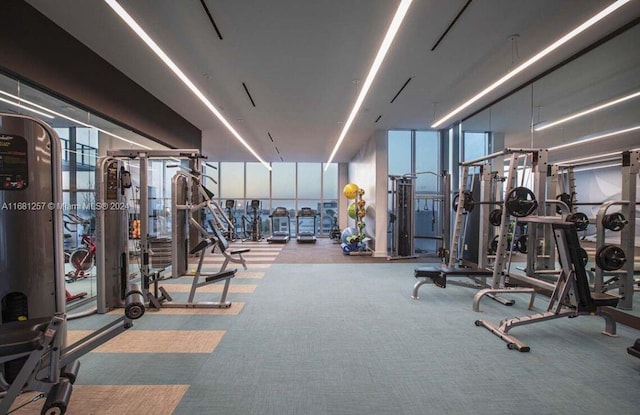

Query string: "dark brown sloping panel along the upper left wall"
[[0, 0, 201, 148]]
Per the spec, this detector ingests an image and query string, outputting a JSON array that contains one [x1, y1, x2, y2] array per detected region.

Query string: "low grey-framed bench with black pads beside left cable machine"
[[147, 238, 237, 309]]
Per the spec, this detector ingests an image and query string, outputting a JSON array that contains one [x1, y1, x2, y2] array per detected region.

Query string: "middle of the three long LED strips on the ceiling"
[[325, 0, 413, 171]]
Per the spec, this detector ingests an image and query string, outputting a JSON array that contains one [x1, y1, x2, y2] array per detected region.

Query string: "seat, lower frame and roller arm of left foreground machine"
[[0, 286, 144, 414]]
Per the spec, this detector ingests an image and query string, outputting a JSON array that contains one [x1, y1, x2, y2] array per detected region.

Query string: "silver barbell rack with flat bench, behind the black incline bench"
[[413, 149, 547, 310]]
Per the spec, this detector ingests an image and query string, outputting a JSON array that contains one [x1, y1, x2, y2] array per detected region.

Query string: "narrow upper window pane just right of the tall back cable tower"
[[416, 131, 440, 193]]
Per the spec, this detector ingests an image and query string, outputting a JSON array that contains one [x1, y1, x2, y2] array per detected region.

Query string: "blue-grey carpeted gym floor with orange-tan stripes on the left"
[[10, 240, 640, 415]]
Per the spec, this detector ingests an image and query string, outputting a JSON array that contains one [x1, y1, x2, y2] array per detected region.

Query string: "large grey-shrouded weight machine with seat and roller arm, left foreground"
[[0, 114, 145, 415]]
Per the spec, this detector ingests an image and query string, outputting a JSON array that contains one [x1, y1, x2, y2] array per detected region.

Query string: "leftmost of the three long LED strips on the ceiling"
[[104, 0, 271, 170]]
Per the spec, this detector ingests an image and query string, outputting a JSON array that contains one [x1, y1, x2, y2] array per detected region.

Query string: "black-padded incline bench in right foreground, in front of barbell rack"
[[475, 222, 620, 354]]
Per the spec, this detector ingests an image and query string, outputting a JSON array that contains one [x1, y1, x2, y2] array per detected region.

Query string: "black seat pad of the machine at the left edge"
[[0, 317, 51, 356]]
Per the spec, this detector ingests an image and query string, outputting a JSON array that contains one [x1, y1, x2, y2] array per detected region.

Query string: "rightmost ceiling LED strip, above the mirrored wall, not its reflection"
[[431, 0, 631, 128]]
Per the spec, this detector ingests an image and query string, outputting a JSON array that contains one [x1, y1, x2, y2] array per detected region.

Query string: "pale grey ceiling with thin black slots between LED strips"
[[22, 0, 640, 162]]
